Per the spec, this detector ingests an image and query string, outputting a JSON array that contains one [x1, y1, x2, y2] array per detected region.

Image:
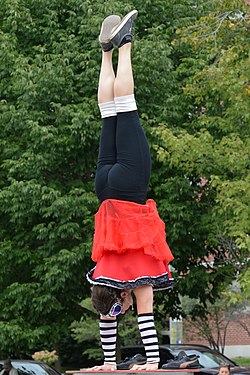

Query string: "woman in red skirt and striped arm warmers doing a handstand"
[[87, 10, 173, 371]]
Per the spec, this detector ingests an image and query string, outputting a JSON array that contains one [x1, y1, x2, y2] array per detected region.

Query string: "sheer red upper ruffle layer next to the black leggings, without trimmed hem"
[[92, 199, 174, 263]]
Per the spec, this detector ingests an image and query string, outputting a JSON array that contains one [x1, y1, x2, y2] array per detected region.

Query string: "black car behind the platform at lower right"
[[122, 344, 250, 375]]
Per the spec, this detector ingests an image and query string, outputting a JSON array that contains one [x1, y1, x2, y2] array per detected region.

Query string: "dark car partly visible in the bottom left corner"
[[0, 359, 61, 375]]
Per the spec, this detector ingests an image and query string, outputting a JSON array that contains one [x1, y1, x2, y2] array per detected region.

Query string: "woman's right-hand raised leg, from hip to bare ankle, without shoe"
[[109, 43, 151, 203]]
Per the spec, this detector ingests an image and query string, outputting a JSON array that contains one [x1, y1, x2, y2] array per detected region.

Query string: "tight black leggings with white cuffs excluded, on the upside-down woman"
[[95, 111, 151, 204]]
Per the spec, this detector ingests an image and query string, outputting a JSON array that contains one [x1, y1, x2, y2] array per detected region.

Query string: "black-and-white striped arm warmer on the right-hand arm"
[[138, 313, 160, 363]]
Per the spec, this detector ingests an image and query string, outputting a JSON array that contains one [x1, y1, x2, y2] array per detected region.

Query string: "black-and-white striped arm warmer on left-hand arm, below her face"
[[99, 318, 117, 364]]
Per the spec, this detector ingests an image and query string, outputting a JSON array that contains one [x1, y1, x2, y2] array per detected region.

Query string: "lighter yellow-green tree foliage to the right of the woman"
[[155, 1, 250, 314]]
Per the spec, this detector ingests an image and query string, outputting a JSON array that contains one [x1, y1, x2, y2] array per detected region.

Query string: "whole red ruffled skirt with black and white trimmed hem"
[[87, 199, 173, 290]]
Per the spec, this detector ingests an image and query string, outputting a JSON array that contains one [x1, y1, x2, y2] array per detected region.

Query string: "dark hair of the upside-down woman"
[[91, 285, 121, 315]]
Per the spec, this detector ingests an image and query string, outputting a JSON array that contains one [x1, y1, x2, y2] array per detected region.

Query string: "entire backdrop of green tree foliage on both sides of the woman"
[[0, 0, 249, 362]]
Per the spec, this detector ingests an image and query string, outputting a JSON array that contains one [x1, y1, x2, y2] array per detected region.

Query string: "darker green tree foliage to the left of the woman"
[[0, 0, 100, 354]]
